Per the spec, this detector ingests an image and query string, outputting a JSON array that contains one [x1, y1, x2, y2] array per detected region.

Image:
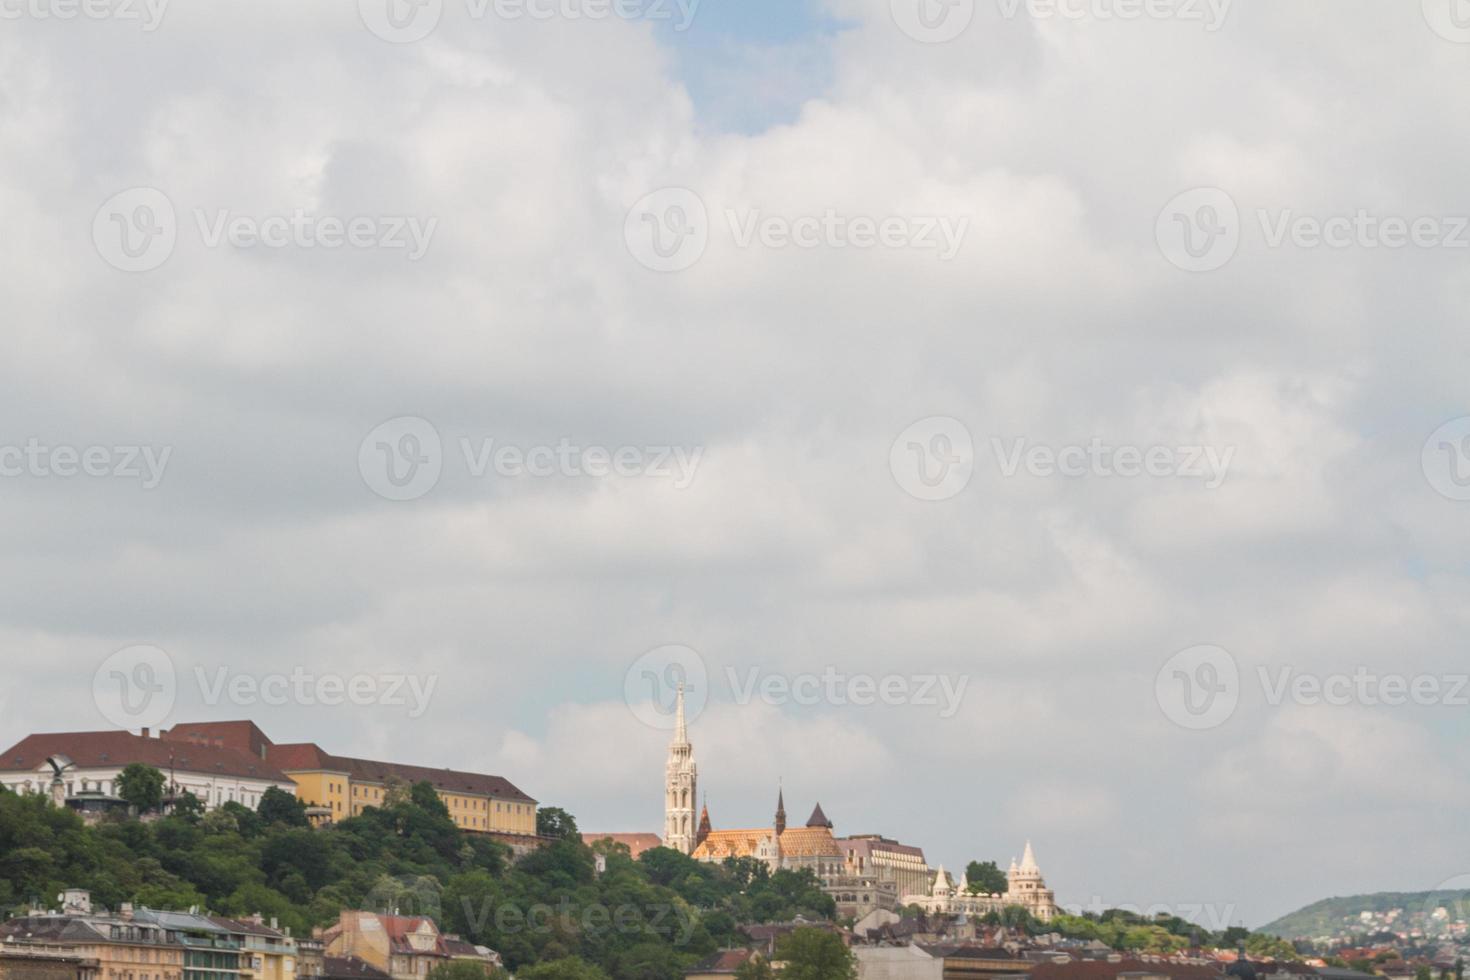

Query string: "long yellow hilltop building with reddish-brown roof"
[[166, 721, 537, 845]]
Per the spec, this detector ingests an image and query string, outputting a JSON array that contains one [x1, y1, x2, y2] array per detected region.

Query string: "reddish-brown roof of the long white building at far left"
[[0, 732, 291, 786]]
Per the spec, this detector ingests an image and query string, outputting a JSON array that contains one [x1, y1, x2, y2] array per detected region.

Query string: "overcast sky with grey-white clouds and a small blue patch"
[[0, 0, 1470, 926]]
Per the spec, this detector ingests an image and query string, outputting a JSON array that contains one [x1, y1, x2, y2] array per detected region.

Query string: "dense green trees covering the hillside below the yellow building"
[[0, 783, 835, 980]]
